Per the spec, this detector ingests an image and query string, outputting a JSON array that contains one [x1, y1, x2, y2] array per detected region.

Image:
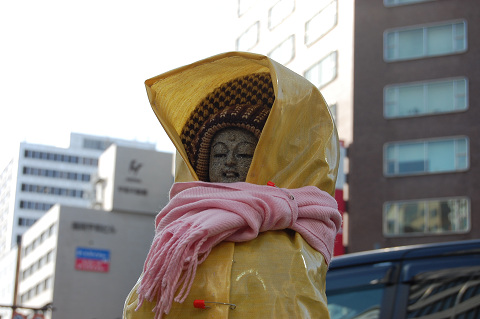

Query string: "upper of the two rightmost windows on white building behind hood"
[[305, 0, 338, 45]]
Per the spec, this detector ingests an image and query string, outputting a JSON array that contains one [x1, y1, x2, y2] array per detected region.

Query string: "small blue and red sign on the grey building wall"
[[75, 247, 110, 272]]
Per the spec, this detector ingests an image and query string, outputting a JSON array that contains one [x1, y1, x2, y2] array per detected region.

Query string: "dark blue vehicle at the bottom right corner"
[[326, 240, 480, 319]]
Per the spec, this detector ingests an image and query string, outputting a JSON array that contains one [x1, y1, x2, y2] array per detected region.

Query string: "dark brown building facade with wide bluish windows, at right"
[[349, 0, 480, 252]]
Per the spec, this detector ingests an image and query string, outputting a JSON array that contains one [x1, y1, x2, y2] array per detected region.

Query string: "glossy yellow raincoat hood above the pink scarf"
[[145, 52, 339, 196]]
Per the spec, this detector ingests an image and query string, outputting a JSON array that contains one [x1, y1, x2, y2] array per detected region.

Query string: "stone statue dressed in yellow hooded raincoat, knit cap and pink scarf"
[[123, 52, 341, 319]]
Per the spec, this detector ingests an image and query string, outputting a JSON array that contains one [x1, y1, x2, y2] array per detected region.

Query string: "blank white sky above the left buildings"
[[0, 0, 238, 170]]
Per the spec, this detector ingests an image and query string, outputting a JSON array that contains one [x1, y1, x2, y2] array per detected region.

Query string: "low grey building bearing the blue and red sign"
[[18, 205, 154, 319]]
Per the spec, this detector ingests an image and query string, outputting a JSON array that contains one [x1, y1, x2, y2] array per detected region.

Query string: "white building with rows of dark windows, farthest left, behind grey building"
[[0, 133, 155, 256]]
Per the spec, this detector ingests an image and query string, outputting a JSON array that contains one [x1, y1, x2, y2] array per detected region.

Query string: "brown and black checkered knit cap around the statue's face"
[[180, 73, 275, 181]]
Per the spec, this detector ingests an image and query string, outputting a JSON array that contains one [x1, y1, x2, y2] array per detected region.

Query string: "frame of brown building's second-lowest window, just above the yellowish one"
[[383, 135, 470, 178]]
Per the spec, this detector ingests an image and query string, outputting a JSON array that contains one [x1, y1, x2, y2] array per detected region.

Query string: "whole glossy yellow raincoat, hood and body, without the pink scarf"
[[123, 52, 339, 319]]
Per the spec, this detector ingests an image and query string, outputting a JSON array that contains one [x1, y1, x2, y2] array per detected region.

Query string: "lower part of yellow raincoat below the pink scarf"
[[123, 231, 329, 319]]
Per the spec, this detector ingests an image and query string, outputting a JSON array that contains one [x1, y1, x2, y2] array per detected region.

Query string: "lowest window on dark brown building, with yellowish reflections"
[[383, 197, 470, 236]]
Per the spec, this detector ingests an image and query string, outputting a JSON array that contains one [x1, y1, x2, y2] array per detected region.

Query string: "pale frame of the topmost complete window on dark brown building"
[[383, 19, 468, 63]]
